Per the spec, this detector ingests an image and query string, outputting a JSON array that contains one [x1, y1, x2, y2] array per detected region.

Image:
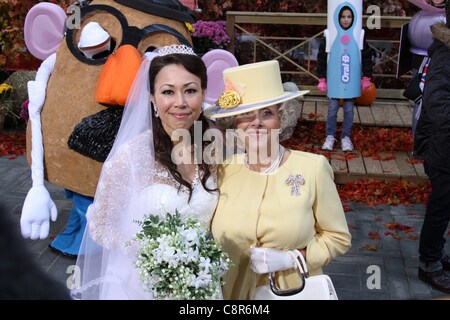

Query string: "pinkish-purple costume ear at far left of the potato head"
[[24, 2, 67, 60]]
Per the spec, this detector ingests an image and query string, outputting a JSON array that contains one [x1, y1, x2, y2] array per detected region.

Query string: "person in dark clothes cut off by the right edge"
[[414, 2, 450, 293]]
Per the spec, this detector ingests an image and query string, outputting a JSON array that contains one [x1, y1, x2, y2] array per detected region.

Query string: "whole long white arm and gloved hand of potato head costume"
[[20, 54, 58, 240]]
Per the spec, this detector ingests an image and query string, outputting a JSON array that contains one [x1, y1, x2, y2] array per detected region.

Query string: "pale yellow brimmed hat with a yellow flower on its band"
[[205, 60, 309, 118]]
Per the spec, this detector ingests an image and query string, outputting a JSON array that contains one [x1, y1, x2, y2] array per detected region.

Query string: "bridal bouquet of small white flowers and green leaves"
[[128, 212, 231, 300]]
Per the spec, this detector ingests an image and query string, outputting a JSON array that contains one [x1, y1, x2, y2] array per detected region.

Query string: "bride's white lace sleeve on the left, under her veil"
[[88, 145, 130, 249]]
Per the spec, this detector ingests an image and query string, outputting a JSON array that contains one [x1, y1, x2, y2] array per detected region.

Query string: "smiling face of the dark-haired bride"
[[151, 64, 204, 136]]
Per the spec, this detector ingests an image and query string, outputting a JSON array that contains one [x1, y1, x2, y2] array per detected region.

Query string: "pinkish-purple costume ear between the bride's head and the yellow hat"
[[202, 49, 239, 105]]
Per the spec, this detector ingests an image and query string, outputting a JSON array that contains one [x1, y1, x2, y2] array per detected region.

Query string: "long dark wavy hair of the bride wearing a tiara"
[[149, 54, 217, 199]]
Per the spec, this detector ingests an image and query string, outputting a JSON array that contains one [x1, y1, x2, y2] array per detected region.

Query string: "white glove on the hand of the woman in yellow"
[[249, 248, 296, 274]]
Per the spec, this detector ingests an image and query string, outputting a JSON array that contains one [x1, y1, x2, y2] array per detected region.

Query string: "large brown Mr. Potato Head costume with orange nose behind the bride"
[[20, 0, 238, 257]]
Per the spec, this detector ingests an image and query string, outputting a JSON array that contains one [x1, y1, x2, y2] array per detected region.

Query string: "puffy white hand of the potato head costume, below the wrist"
[[20, 185, 58, 240]]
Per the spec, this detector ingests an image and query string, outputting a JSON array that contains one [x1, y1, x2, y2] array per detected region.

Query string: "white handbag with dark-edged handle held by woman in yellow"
[[253, 250, 338, 300]]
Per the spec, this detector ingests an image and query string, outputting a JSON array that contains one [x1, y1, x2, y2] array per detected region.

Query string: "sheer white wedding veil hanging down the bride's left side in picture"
[[68, 52, 158, 299]]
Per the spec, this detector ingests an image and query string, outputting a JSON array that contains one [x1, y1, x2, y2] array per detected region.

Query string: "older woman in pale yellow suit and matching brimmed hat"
[[206, 61, 351, 299]]
